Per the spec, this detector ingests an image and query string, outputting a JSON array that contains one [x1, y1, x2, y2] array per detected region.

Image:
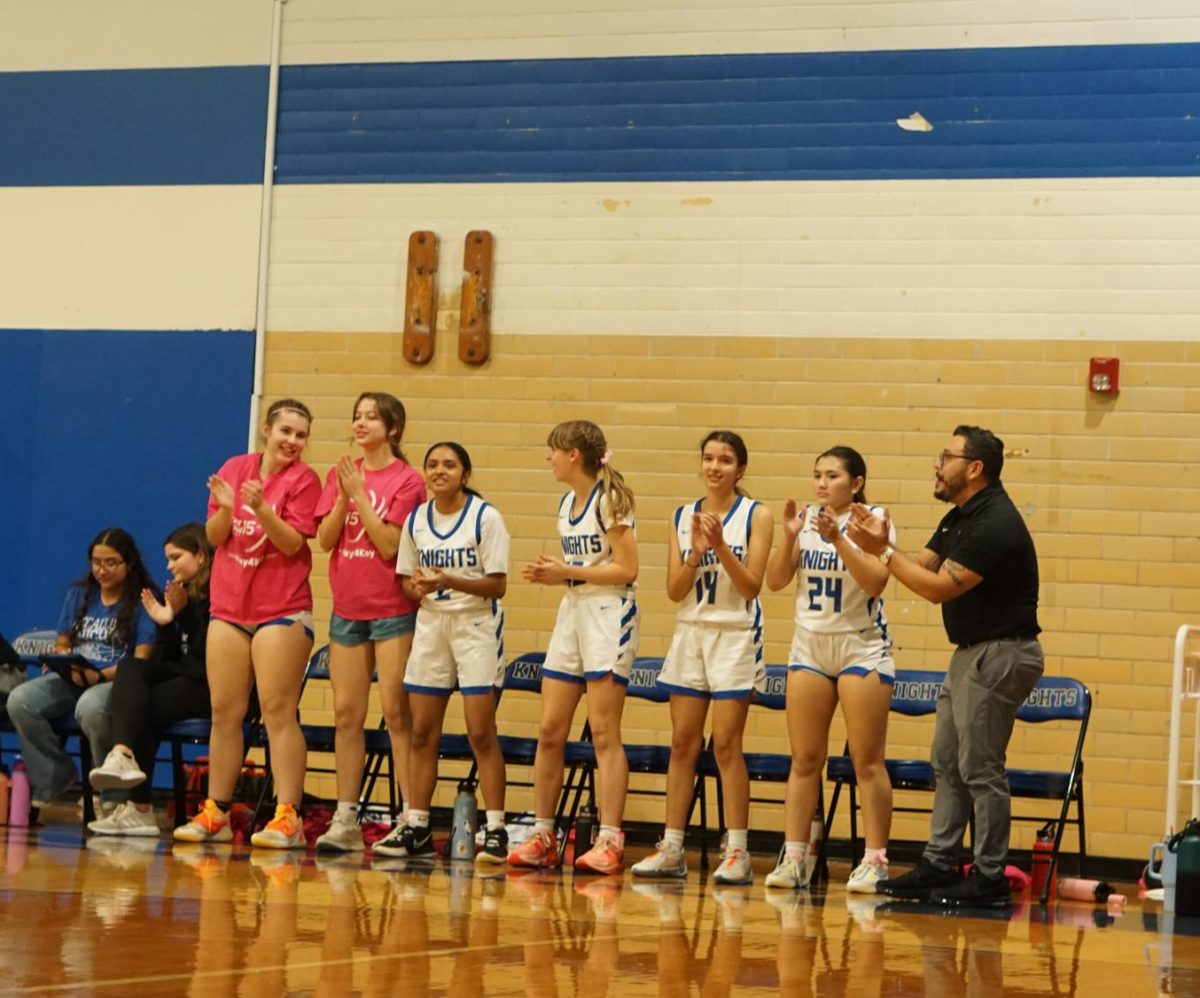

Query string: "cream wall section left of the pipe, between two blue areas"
[[0, 186, 262, 330]]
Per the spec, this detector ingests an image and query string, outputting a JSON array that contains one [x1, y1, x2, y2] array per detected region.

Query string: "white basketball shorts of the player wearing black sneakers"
[[404, 609, 504, 697]]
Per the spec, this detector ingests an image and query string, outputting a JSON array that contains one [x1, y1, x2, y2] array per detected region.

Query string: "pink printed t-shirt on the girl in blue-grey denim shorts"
[[317, 458, 425, 620]]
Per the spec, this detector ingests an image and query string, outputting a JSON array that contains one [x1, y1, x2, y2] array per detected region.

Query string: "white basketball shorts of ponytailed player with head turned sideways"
[[541, 593, 638, 685]]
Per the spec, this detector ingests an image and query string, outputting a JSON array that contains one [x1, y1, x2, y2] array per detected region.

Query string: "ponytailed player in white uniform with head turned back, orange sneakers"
[[509, 420, 637, 873]]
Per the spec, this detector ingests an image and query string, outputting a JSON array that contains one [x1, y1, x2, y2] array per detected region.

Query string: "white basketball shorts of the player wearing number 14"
[[659, 623, 767, 699]]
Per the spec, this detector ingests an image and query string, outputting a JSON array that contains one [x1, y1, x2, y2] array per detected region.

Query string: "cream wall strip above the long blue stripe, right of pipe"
[[283, 0, 1200, 64]]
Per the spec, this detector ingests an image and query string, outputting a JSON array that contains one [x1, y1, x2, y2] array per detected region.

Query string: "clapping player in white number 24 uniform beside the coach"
[[766, 446, 895, 894]]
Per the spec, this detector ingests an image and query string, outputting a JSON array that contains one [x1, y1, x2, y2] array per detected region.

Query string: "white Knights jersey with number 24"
[[796, 506, 895, 637]]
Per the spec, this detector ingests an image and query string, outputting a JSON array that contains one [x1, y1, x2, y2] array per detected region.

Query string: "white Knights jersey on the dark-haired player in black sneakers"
[[396, 495, 509, 613]]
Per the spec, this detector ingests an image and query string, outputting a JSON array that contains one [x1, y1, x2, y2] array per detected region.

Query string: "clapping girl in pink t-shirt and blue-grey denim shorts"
[[317, 391, 425, 853]]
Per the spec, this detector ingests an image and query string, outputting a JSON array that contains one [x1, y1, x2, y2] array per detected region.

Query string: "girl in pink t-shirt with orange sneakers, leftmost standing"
[[175, 398, 320, 849]]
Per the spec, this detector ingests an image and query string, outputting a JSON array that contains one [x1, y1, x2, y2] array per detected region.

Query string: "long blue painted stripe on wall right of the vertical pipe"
[[276, 44, 1200, 184]]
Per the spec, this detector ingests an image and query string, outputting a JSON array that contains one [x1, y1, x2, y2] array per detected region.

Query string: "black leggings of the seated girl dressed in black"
[[108, 659, 212, 804]]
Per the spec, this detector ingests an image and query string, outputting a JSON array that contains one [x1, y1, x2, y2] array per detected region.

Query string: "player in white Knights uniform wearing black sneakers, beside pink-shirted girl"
[[373, 441, 509, 864]]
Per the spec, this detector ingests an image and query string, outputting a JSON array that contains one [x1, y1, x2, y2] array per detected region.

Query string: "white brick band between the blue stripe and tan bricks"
[[268, 180, 1200, 339]]
